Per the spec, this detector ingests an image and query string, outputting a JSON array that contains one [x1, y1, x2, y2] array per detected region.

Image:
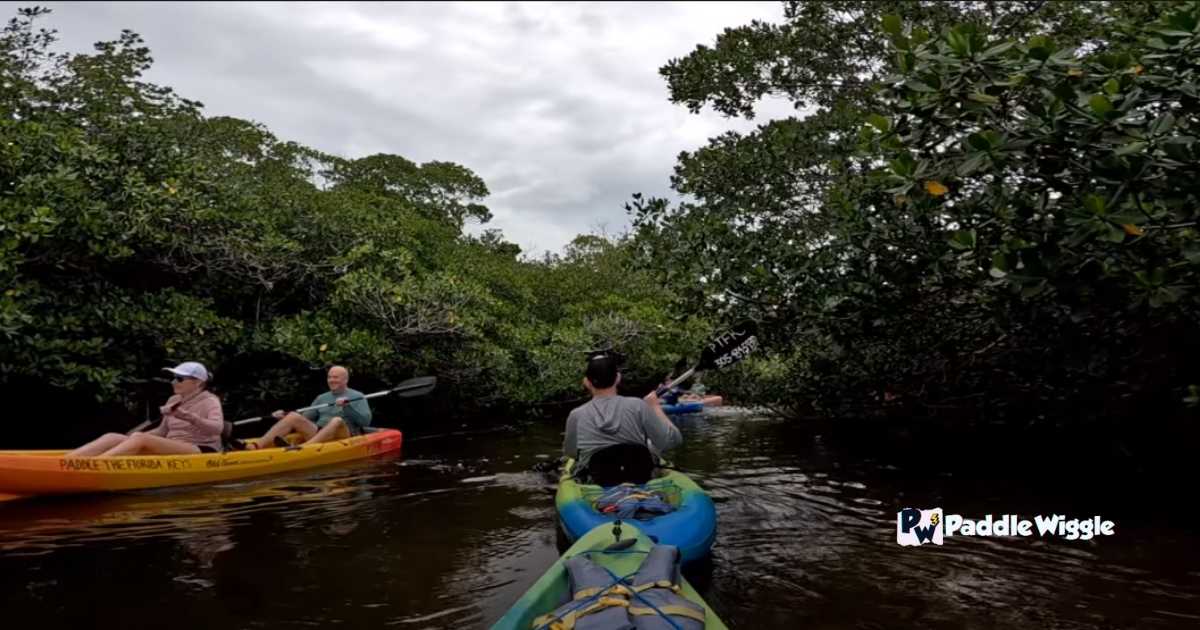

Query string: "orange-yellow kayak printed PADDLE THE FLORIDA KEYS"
[[0, 428, 403, 500]]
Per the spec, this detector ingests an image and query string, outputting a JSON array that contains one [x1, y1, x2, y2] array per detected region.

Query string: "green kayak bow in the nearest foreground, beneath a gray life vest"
[[492, 521, 726, 630]]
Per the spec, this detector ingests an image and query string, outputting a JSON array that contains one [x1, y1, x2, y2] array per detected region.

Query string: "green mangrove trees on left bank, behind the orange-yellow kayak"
[[0, 10, 708, 422]]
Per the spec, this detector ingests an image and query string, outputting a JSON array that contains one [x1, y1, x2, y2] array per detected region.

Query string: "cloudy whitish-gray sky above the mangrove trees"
[[9, 1, 791, 256]]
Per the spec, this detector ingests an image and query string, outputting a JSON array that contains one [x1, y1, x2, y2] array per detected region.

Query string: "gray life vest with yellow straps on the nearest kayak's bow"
[[533, 545, 704, 630]]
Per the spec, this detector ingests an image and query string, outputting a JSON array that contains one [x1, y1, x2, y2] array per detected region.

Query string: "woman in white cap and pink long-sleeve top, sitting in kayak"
[[66, 361, 224, 457]]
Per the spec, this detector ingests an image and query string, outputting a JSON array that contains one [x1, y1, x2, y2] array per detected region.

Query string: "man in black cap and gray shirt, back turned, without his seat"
[[563, 354, 683, 482]]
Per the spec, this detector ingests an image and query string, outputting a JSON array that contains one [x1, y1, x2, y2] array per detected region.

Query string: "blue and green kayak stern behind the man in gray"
[[554, 460, 716, 563]]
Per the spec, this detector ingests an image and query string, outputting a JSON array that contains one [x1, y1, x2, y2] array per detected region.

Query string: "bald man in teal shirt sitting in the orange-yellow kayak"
[[247, 365, 371, 449]]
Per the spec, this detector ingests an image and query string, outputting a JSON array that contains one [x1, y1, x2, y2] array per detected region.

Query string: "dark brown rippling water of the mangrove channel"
[[0, 410, 1200, 630]]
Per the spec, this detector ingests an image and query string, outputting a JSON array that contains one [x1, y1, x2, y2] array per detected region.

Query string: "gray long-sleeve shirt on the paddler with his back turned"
[[563, 396, 683, 469]]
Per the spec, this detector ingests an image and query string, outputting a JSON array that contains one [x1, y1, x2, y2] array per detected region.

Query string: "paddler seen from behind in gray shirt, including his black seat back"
[[563, 353, 683, 486]]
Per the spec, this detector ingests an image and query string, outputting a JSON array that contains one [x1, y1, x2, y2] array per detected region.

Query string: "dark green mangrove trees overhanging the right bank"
[[630, 1, 1200, 422]]
